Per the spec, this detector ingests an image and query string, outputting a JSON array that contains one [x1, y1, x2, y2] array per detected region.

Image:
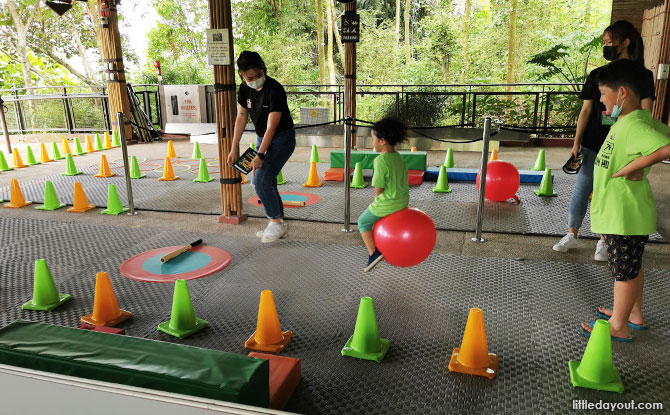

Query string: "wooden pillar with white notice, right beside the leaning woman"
[[209, 0, 247, 223]]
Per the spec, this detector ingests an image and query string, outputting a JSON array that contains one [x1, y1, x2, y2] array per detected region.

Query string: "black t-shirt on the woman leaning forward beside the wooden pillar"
[[237, 76, 293, 137]]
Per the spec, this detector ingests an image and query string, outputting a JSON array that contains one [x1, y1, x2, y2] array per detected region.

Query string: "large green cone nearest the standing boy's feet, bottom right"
[[568, 320, 623, 393]]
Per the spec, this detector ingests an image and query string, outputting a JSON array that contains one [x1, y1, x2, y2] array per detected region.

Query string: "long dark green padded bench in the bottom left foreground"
[[0, 320, 270, 408]]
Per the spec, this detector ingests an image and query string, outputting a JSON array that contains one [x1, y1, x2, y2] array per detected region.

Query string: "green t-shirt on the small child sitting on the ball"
[[368, 152, 409, 217]]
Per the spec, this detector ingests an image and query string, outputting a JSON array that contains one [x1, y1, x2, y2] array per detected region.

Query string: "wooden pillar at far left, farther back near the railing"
[[97, 0, 133, 140]]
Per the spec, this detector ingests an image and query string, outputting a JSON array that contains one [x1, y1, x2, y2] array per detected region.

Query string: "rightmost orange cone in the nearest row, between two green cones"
[[449, 308, 498, 379]]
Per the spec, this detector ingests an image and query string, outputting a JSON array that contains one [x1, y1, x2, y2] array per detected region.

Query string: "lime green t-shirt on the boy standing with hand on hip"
[[591, 110, 670, 235]]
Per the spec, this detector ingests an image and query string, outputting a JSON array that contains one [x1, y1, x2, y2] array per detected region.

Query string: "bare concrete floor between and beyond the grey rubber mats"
[[0, 137, 670, 272]]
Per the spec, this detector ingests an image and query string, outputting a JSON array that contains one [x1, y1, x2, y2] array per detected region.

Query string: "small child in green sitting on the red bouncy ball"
[[358, 117, 409, 272]]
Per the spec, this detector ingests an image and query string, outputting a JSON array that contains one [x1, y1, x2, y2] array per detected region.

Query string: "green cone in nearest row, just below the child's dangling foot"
[[342, 297, 391, 362]]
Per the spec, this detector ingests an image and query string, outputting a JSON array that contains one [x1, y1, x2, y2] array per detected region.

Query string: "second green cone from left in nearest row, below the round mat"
[[158, 280, 209, 339]]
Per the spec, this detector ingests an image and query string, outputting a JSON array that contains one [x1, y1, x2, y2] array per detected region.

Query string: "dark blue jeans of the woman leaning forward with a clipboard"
[[251, 128, 295, 219]]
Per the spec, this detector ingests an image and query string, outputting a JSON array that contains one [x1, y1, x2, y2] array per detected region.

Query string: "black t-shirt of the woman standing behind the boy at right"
[[579, 67, 656, 152]]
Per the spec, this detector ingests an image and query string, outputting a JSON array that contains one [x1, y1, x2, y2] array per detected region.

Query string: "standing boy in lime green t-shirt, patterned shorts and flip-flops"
[[580, 59, 670, 342]]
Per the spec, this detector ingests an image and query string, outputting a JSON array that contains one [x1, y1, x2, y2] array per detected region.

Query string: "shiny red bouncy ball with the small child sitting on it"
[[372, 208, 437, 267]]
